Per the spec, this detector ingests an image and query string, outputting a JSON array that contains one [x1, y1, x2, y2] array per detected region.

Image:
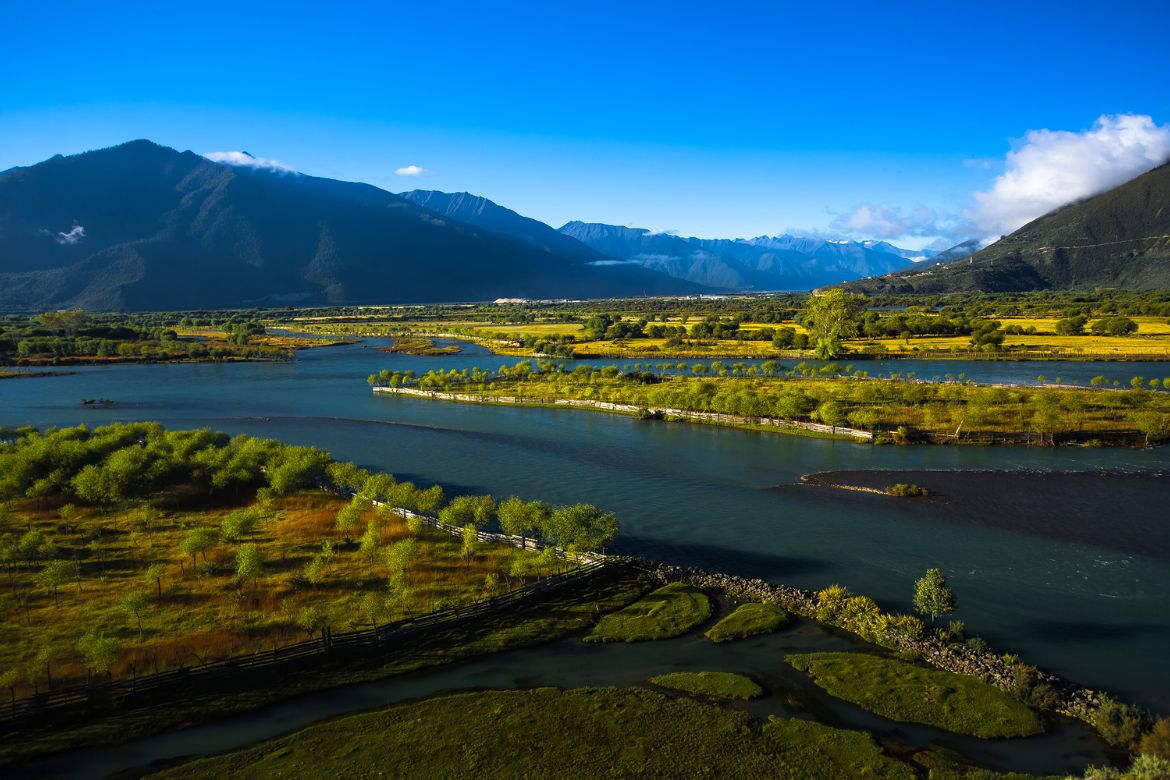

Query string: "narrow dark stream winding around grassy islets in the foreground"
[[21, 617, 1106, 780]]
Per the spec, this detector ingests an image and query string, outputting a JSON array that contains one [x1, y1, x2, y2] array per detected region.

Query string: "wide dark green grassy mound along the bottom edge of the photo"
[[146, 688, 915, 780]]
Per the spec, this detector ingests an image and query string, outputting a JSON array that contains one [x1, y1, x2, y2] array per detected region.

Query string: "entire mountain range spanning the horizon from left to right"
[[9, 140, 1170, 310]]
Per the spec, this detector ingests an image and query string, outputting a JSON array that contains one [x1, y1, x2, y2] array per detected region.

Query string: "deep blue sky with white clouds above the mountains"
[[0, 0, 1170, 248]]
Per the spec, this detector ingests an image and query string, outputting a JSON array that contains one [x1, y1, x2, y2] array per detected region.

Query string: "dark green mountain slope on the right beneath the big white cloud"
[[847, 164, 1170, 292]]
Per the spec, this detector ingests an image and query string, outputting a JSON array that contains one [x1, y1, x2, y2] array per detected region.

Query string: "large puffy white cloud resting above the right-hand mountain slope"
[[972, 113, 1170, 240]]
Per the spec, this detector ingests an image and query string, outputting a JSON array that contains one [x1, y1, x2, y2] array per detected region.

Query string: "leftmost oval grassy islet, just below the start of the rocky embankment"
[[585, 582, 711, 642]]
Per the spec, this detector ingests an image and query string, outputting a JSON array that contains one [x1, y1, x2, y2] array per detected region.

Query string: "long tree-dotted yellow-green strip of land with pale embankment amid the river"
[[369, 360, 1170, 443]]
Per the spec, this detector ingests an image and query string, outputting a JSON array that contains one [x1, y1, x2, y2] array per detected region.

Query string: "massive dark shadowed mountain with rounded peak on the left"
[[0, 140, 701, 310]]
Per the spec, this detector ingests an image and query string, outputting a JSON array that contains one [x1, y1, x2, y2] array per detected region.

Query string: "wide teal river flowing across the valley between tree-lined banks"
[[0, 339, 1170, 710]]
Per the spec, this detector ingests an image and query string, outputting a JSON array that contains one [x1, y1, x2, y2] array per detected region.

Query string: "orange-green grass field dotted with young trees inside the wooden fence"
[[0, 489, 559, 696]]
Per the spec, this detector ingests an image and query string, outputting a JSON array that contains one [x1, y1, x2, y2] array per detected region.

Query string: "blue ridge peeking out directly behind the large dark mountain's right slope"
[[400, 189, 606, 263]]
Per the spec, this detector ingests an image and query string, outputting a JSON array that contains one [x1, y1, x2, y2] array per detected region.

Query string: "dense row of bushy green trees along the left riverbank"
[[0, 422, 618, 551]]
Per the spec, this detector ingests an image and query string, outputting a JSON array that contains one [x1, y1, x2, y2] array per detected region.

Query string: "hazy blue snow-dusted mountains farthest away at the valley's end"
[[560, 222, 914, 291]]
